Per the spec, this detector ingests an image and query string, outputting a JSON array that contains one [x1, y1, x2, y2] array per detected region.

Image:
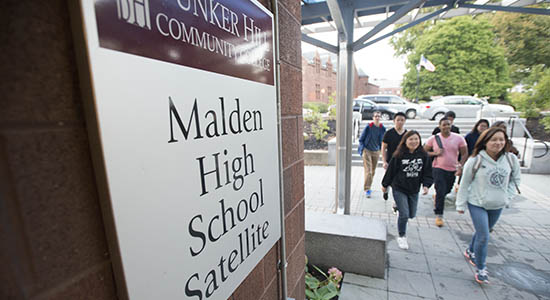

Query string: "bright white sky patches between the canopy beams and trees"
[[302, 26, 407, 84]]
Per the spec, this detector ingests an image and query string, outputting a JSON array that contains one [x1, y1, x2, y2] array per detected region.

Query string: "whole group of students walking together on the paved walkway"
[[358, 111, 520, 283]]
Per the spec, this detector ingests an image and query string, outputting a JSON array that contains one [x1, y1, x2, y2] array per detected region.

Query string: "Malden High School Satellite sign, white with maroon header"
[[74, 0, 280, 300]]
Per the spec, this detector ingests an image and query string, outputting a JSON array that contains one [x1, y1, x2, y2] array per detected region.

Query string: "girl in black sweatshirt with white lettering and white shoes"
[[382, 130, 433, 250]]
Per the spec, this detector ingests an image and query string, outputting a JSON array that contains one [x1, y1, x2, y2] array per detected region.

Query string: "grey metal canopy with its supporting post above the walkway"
[[302, 0, 550, 214]]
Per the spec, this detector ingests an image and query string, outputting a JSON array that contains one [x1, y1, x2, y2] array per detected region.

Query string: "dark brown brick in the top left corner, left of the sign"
[[0, 0, 83, 123]]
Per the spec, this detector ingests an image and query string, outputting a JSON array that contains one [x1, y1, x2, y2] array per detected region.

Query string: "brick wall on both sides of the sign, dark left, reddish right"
[[0, 0, 305, 300]]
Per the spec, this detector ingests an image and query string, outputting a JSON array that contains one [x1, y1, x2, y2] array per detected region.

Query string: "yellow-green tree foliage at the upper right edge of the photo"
[[485, 8, 550, 83]]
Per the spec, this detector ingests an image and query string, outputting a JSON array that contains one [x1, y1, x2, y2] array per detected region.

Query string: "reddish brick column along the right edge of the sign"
[[232, 0, 305, 300]]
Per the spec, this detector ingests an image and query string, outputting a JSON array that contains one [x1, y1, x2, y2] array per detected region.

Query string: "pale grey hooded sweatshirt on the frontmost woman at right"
[[456, 150, 521, 211]]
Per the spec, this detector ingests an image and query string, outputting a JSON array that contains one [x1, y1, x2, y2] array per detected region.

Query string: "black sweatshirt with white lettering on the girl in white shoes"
[[382, 147, 433, 195]]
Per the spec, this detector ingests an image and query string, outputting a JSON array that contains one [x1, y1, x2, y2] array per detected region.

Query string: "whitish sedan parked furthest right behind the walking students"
[[420, 95, 514, 120]]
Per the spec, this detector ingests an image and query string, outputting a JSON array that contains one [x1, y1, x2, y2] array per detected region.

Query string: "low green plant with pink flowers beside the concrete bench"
[[305, 262, 342, 300]]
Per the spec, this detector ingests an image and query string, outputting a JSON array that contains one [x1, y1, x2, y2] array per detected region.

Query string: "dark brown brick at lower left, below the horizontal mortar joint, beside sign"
[[3, 128, 109, 290]]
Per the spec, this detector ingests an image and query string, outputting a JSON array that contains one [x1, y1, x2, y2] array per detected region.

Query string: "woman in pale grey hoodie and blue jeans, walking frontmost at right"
[[456, 127, 521, 283]]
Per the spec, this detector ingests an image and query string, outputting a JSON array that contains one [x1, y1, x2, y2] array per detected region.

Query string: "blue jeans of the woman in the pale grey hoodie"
[[468, 203, 502, 270]]
